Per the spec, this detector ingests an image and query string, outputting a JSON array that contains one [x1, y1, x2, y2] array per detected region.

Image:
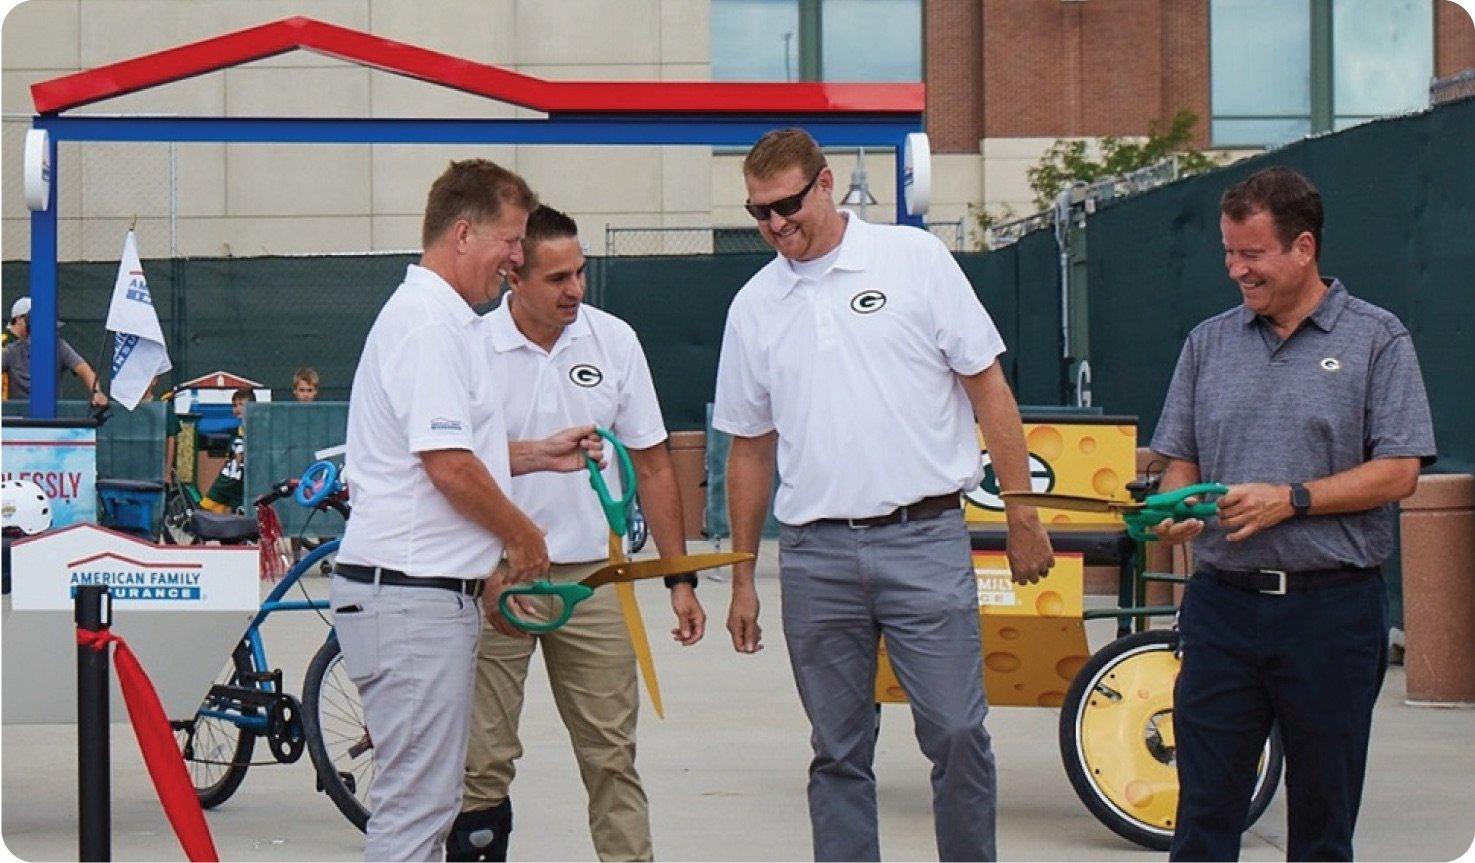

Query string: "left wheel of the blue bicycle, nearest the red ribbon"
[[174, 646, 257, 808]]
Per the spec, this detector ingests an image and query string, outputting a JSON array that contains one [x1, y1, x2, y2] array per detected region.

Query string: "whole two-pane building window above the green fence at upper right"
[[1210, 0, 1438, 146]]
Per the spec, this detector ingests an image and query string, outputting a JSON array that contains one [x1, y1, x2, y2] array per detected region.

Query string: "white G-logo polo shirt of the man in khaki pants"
[[487, 294, 665, 564]]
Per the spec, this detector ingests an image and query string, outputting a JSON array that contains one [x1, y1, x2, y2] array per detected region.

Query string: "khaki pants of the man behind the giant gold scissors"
[[462, 562, 652, 860]]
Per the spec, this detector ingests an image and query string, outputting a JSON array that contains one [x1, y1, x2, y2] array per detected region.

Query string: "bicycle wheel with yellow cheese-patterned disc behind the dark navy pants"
[[1061, 630, 1283, 851]]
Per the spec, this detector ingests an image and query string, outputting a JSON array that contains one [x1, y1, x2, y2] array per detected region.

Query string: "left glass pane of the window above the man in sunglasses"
[[711, 0, 799, 81]]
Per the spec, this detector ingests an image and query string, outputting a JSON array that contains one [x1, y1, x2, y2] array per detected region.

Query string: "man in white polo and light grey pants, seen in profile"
[[330, 159, 600, 860]]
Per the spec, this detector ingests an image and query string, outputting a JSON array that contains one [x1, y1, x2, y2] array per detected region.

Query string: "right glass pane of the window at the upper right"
[[1332, 0, 1434, 117]]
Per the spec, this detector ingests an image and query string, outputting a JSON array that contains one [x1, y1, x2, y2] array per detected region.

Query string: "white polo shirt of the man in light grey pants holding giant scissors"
[[338, 264, 512, 578]]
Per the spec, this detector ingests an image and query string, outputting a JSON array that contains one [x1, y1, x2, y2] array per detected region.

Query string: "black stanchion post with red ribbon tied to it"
[[74, 584, 112, 863]]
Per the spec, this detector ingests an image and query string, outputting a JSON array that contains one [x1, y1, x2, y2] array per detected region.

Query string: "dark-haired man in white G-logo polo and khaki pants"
[[447, 207, 707, 860]]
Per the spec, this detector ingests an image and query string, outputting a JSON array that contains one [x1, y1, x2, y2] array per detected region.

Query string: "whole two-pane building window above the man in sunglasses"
[[711, 0, 922, 81]]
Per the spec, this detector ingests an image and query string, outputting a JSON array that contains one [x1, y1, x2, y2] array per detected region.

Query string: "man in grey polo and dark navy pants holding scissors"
[[1152, 168, 1435, 860]]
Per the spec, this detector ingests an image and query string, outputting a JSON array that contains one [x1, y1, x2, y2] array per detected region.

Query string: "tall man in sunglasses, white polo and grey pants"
[[712, 128, 1055, 860]]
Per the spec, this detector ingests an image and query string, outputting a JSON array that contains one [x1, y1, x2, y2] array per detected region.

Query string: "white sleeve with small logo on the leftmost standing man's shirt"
[[384, 323, 473, 453]]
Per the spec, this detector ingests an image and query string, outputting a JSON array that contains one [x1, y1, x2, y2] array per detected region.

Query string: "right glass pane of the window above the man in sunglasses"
[[820, 0, 922, 81]]
